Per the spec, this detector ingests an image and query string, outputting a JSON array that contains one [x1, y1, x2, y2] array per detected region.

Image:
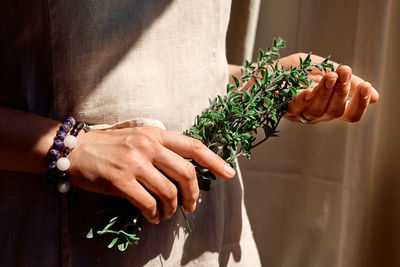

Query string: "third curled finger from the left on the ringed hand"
[[340, 82, 372, 122]]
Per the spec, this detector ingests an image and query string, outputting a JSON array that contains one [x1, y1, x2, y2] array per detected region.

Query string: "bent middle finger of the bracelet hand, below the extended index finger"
[[153, 148, 199, 212]]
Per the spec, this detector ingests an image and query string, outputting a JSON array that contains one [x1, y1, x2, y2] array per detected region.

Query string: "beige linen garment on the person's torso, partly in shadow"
[[0, 0, 260, 266]]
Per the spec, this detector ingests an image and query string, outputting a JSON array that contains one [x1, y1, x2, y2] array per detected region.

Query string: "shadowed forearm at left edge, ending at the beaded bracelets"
[[0, 106, 60, 173]]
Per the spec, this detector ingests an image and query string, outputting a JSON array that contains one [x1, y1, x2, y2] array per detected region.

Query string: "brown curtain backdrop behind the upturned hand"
[[227, 0, 400, 267]]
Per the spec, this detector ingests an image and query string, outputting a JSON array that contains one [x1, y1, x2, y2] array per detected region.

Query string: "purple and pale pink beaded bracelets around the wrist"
[[47, 117, 89, 193]]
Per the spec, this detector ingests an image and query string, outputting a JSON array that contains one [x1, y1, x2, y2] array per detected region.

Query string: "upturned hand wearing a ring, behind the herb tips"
[[279, 53, 379, 123]]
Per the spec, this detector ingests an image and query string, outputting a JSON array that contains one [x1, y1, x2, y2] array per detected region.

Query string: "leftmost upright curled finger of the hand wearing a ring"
[[302, 72, 342, 120]]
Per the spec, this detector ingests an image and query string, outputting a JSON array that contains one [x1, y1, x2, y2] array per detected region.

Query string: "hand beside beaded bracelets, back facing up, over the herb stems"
[[69, 126, 235, 223]]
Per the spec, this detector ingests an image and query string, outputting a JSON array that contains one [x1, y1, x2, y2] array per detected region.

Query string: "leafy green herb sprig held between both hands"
[[87, 38, 334, 251]]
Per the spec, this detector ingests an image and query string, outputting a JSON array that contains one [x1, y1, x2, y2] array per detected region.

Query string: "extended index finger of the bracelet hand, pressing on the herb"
[[160, 131, 235, 178]]
